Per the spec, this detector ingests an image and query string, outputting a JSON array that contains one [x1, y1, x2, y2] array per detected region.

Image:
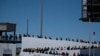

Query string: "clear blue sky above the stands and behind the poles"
[[0, 0, 100, 41]]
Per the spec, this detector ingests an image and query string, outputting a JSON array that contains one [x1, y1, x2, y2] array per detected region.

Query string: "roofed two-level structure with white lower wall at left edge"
[[0, 23, 18, 56]]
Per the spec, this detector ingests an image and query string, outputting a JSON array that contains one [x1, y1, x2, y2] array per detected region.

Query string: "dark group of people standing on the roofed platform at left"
[[0, 34, 22, 43]]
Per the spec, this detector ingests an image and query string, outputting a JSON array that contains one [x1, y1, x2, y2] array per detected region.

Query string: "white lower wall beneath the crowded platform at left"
[[0, 43, 16, 56]]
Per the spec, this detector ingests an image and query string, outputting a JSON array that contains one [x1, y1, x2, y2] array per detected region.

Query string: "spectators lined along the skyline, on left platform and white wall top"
[[0, 34, 100, 44]]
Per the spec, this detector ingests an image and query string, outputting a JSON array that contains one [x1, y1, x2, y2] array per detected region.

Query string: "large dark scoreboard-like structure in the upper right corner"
[[80, 0, 100, 22]]
